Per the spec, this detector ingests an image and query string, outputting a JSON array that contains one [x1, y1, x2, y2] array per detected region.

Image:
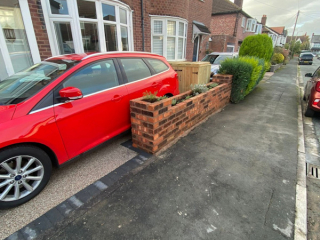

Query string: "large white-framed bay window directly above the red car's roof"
[[41, 0, 133, 55]]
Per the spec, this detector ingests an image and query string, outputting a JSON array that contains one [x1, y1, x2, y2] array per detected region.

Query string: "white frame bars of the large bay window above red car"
[[41, 0, 134, 56]]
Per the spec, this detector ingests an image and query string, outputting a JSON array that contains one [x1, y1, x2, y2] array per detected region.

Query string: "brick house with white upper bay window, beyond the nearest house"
[[209, 0, 262, 52]]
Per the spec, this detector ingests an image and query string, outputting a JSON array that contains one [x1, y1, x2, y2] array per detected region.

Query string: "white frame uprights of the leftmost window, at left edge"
[[0, 0, 41, 76]]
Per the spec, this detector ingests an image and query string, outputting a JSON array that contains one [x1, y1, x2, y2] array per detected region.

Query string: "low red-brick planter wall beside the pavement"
[[130, 74, 232, 153]]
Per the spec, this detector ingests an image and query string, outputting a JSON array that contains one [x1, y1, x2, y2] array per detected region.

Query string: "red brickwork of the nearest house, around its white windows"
[[28, 0, 212, 61]]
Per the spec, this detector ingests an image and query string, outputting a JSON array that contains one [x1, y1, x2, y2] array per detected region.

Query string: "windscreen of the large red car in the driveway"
[[0, 59, 78, 105]]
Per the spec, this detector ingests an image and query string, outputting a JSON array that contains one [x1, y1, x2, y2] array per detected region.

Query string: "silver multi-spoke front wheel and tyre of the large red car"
[[0, 145, 52, 209]]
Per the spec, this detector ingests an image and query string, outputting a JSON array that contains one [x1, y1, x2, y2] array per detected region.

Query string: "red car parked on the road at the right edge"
[[303, 67, 320, 117]]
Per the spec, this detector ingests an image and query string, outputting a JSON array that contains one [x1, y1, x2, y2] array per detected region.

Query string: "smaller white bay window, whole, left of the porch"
[[151, 16, 187, 60]]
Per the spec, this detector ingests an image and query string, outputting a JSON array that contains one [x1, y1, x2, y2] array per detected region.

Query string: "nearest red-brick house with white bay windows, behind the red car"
[[0, 0, 212, 80]]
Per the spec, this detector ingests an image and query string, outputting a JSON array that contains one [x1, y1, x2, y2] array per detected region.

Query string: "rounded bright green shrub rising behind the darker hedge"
[[239, 34, 273, 62]]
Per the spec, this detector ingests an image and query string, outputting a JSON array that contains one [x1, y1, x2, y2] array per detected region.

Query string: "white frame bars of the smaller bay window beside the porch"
[[150, 15, 188, 61]]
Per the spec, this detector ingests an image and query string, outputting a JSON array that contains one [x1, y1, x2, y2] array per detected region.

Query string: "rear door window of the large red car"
[[120, 58, 151, 82]]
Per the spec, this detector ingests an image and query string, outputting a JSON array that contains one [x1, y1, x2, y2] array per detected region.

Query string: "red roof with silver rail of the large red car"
[[46, 51, 163, 61]]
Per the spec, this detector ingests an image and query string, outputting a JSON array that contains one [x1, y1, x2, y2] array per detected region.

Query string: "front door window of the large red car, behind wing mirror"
[[63, 59, 119, 96]]
